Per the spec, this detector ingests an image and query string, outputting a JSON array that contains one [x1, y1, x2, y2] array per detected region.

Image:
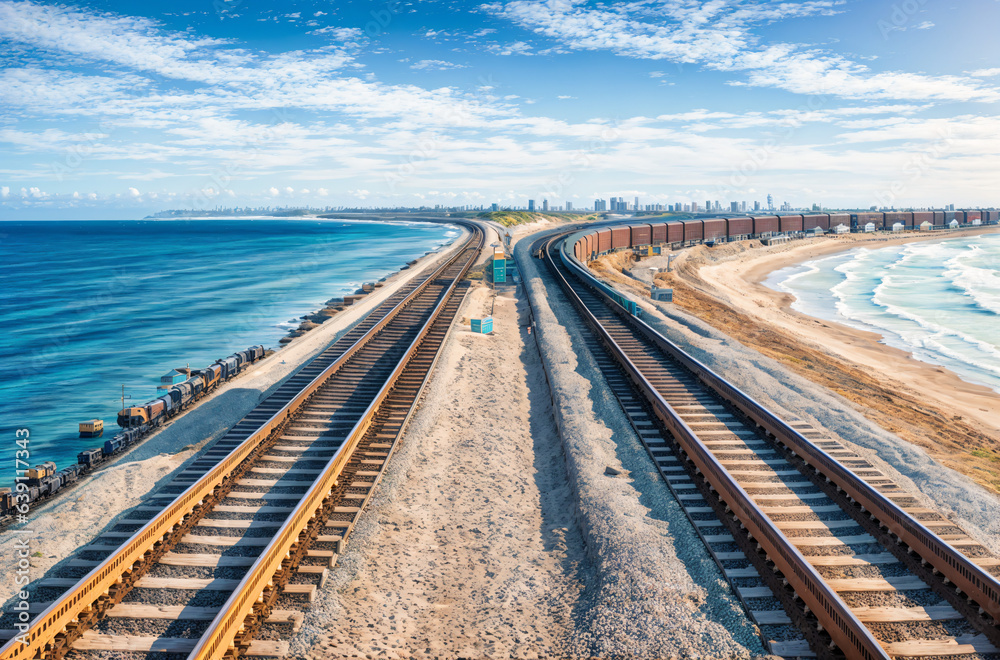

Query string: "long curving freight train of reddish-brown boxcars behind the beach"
[[573, 210, 1000, 262]]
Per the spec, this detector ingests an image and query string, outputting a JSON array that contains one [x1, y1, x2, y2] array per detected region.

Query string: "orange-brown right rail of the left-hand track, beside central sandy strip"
[[188, 227, 485, 660]]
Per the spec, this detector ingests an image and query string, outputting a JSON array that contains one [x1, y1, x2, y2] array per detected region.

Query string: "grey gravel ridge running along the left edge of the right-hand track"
[[516, 229, 763, 658]]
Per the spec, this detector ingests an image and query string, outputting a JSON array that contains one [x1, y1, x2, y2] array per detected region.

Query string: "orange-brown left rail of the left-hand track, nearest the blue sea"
[[0, 221, 483, 660]]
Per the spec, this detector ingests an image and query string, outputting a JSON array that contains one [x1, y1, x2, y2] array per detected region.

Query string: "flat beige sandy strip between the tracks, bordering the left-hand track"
[[293, 284, 588, 658]]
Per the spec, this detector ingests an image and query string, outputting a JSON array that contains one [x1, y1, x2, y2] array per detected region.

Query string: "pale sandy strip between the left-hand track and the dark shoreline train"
[[0, 232, 466, 602]]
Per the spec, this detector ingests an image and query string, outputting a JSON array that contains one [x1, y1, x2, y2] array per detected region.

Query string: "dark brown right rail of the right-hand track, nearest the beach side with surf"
[[560, 226, 1000, 634]]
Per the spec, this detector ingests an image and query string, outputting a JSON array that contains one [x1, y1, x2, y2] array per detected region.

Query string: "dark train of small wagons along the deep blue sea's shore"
[[0, 345, 264, 525]]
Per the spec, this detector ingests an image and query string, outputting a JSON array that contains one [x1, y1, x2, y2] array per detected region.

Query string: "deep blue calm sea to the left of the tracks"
[[0, 219, 458, 476]]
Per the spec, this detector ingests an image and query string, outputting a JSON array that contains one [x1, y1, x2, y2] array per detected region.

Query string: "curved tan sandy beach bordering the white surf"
[[595, 227, 1000, 492]]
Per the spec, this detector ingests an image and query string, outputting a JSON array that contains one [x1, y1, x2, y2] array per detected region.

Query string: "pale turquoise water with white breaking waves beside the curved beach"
[[765, 234, 1000, 392]]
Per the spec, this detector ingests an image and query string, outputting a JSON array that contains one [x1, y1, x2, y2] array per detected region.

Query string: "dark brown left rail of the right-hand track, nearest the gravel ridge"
[[545, 235, 890, 660]]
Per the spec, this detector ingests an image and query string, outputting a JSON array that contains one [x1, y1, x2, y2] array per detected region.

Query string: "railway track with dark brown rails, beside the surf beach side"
[[532, 229, 1000, 659]]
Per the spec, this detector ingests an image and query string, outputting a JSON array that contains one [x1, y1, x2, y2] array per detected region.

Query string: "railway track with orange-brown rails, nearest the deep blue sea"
[[0, 225, 484, 660]]
